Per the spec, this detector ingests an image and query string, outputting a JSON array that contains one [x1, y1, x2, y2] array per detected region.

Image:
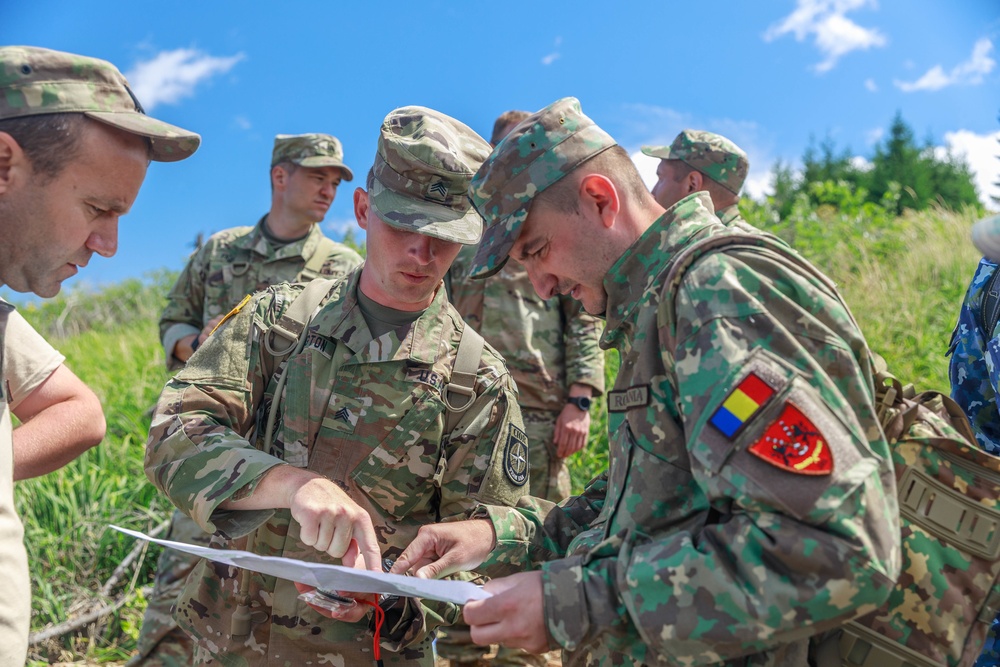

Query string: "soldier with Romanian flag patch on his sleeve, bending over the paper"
[[394, 98, 900, 666]]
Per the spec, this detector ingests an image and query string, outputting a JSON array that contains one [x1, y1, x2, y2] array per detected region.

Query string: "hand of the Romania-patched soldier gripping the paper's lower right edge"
[[462, 571, 549, 653]]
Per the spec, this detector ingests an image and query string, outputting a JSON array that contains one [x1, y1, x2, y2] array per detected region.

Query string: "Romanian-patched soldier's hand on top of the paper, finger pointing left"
[[390, 519, 496, 579]]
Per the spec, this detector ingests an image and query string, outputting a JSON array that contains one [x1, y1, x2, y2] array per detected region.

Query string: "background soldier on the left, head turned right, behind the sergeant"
[[135, 133, 361, 667]]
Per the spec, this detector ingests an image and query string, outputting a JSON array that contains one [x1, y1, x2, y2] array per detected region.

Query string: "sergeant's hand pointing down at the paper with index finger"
[[287, 478, 382, 572]]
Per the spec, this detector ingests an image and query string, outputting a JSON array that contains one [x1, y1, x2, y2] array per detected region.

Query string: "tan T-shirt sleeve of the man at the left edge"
[[3, 310, 66, 412]]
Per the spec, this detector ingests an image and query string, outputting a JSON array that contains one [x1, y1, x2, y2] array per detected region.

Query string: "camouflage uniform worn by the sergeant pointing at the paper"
[[146, 269, 527, 665]]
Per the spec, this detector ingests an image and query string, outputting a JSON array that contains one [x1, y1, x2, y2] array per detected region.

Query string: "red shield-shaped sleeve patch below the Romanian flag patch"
[[750, 403, 833, 475]]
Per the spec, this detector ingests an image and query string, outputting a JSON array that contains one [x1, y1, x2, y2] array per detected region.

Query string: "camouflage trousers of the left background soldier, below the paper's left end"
[[126, 511, 211, 667]]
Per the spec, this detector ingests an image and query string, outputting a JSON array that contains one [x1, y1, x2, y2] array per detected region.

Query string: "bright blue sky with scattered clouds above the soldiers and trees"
[[0, 0, 1000, 301]]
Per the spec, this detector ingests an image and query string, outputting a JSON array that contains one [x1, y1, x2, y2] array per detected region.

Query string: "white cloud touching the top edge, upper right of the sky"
[[764, 0, 887, 73]]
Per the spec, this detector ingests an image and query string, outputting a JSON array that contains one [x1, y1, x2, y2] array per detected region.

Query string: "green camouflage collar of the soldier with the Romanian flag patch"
[[601, 192, 726, 349]]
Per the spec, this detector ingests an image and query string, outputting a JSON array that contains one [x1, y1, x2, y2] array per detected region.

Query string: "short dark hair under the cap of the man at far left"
[[0, 113, 87, 179]]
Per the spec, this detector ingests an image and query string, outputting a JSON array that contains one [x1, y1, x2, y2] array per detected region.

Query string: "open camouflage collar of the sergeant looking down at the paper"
[[313, 267, 453, 365]]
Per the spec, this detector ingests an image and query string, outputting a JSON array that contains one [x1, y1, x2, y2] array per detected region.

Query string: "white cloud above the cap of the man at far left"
[[126, 49, 244, 111]]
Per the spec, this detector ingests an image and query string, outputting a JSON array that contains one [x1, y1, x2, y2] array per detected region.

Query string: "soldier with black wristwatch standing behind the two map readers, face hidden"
[[436, 111, 604, 667]]
